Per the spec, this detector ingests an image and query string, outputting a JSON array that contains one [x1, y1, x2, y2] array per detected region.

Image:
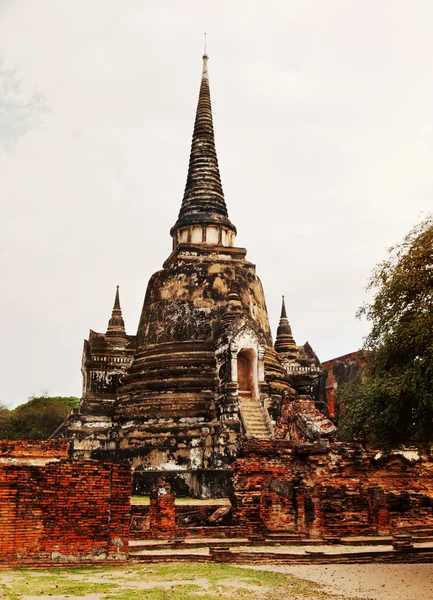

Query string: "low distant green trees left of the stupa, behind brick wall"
[[0, 396, 79, 440]]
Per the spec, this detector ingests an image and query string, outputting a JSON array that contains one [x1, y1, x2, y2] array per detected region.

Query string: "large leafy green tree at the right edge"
[[338, 215, 433, 449]]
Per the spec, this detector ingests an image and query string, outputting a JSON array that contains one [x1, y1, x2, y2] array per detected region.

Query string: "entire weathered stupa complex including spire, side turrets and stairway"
[[56, 55, 335, 497]]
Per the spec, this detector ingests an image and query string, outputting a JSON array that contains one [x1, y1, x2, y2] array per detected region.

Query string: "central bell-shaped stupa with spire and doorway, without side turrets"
[[115, 55, 289, 485]]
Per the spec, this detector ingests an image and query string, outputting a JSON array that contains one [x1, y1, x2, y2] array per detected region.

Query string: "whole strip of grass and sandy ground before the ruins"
[[0, 563, 433, 600]]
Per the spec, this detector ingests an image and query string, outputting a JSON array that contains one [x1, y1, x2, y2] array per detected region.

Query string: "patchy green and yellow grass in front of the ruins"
[[0, 563, 358, 600]]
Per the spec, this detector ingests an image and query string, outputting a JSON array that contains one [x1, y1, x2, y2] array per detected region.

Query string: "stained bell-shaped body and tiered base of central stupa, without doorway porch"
[[110, 244, 280, 478]]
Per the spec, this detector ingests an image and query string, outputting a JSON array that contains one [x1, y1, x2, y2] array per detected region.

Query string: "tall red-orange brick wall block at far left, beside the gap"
[[0, 440, 131, 565]]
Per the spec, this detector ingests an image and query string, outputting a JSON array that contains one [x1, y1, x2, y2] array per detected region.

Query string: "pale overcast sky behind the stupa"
[[0, 0, 433, 406]]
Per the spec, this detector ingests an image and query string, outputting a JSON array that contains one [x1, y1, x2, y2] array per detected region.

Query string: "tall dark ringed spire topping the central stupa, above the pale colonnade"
[[171, 54, 236, 237]]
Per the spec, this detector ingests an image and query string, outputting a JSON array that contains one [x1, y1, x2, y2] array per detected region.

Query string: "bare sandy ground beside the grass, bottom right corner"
[[245, 564, 433, 600]]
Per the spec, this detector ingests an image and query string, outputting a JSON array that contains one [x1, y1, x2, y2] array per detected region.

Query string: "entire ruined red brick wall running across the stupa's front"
[[0, 440, 433, 552]]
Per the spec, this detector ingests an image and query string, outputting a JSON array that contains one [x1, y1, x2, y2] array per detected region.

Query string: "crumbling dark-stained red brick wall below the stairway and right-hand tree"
[[233, 440, 433, 538]]
